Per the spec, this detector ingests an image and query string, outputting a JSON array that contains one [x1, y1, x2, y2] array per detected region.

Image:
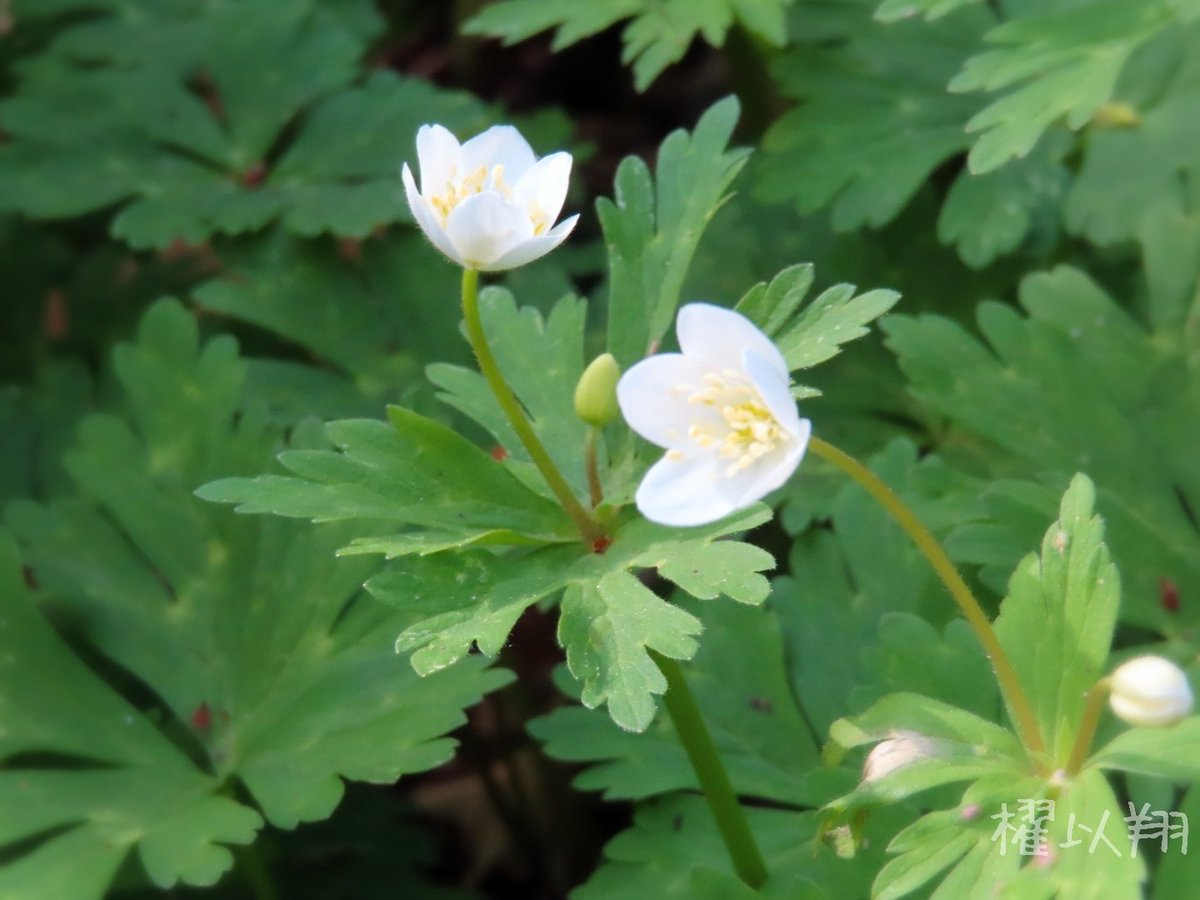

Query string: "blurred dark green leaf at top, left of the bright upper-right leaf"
[[755, 4, 988, 230]]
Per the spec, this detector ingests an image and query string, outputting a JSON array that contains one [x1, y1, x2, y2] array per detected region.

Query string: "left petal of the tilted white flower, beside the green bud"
[[617, 353, 721, 449]]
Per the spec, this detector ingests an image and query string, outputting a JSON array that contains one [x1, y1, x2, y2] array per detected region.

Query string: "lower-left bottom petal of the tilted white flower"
[[635, 455, 737, 527]]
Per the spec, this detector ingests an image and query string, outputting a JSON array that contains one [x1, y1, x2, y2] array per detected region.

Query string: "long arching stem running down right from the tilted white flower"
[[809, 437, 1045, 754]]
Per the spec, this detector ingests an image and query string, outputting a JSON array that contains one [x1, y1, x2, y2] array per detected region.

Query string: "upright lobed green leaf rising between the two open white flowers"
[[596, 97, 748, 367]]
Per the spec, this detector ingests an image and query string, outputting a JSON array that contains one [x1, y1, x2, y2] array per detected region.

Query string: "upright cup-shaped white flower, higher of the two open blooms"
[[402, 125, 580, 272]]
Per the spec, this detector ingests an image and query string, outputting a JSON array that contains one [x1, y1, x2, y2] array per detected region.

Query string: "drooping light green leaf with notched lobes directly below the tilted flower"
[[367, 505, 773, 731]]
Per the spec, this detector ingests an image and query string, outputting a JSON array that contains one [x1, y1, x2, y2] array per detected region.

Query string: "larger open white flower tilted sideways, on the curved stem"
[[617, 304, 812, 526]]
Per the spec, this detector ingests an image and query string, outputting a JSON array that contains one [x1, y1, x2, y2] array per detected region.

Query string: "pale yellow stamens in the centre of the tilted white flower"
[[688, 370, 792, 478]]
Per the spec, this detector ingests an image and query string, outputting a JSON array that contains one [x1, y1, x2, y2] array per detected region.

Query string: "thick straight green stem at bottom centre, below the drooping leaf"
[[650, 652, 767, 889]]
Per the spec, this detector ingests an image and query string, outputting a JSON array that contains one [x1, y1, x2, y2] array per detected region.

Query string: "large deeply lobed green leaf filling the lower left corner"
[[0, 301, 508, 898]]
